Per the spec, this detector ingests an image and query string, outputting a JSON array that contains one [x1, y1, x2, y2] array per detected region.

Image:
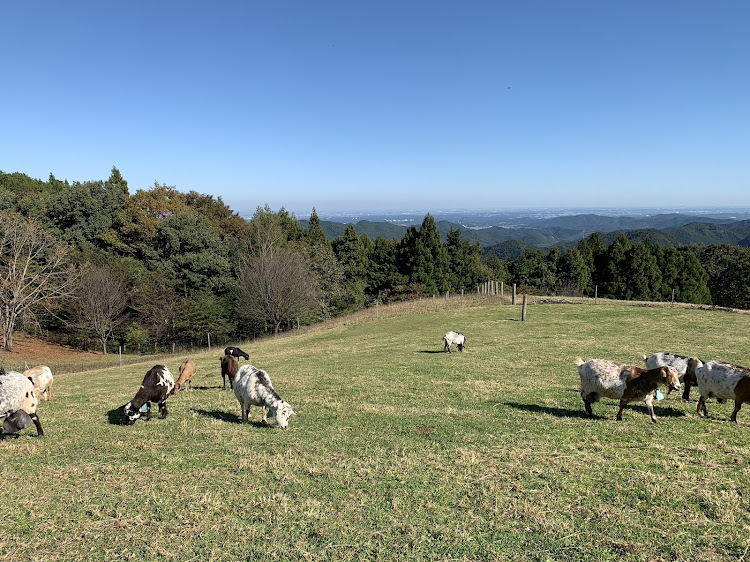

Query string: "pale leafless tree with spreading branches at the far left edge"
[[0, 214, 78, 351]]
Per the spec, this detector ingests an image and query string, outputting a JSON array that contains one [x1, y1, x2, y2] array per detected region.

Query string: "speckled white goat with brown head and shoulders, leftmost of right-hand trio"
[[575, 358, 680, 423]]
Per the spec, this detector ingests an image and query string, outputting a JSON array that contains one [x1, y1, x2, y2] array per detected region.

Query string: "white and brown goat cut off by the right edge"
[[691, 359, 750, 423]]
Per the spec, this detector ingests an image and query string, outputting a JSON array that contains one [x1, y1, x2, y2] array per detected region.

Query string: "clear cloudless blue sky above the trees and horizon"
[[0, 0, 750, 213]]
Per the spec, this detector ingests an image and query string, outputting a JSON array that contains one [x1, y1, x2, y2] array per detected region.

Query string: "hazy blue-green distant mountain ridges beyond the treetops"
[[300, 214, 750, 258]]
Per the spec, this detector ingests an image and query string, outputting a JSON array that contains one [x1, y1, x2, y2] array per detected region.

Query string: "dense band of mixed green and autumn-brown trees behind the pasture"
[[0, 167, 750, 353]]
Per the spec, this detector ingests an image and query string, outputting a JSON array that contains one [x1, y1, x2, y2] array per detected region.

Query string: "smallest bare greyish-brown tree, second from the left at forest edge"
[[78, 267, 128, 355]]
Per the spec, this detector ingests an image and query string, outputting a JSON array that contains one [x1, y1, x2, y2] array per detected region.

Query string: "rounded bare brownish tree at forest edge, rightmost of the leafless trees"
[[238, 244, 320, 334]]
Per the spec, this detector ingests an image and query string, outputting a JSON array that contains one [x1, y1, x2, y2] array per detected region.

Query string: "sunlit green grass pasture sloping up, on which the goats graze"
[[0, 298, 750, 561]]
